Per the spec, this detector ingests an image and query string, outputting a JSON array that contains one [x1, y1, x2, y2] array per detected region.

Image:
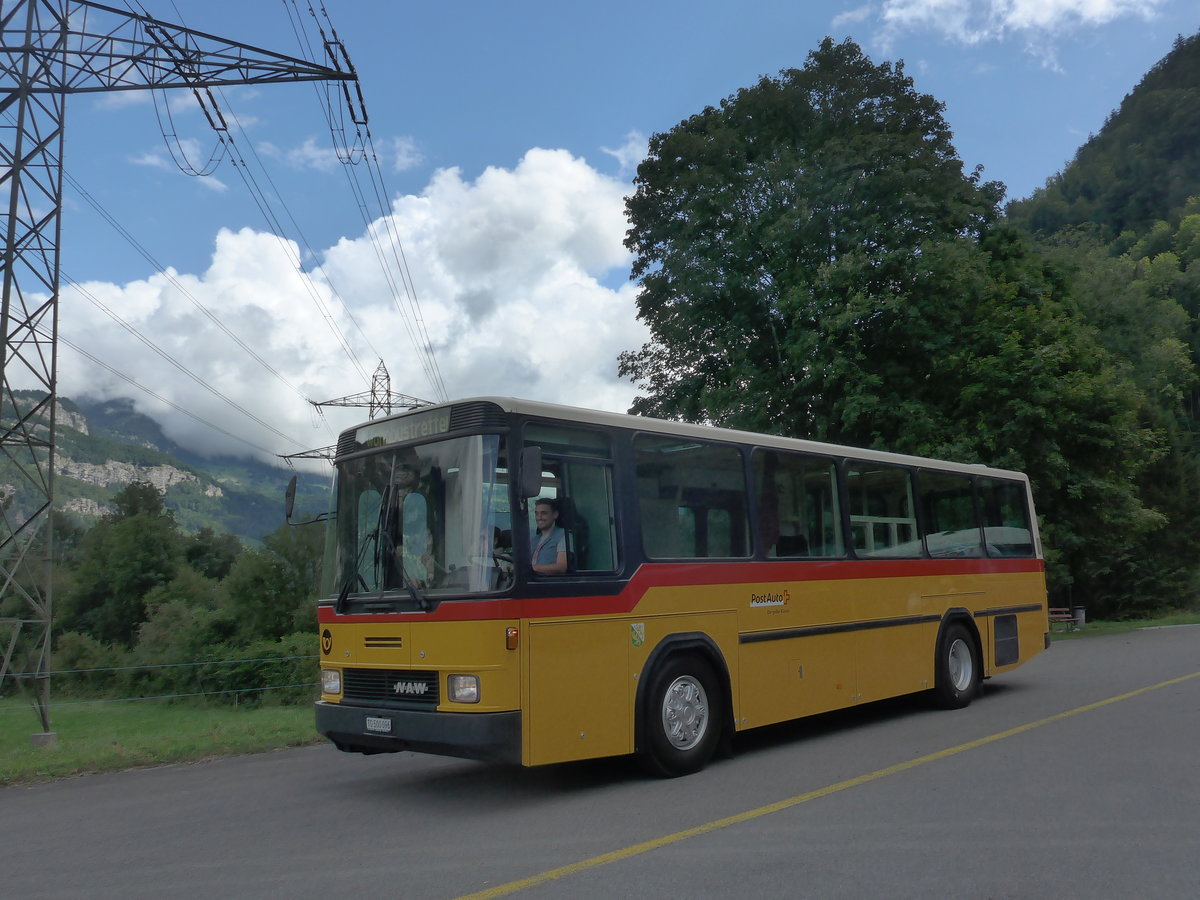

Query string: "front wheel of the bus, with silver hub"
[[637, 653, 725, 778]]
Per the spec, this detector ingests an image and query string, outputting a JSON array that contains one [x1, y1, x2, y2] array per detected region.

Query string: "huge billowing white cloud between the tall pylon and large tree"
[[59, 149, 647, 465]]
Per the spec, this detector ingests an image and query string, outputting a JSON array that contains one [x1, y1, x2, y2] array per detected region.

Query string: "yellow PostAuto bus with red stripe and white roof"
[[317, 397, 1049, 775]]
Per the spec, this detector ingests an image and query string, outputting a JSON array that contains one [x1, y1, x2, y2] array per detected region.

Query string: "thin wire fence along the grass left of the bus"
[[0, 654, 319, 712]]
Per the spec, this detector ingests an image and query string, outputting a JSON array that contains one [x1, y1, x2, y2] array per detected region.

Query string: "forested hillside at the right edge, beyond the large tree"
[[1006, 35, 1200, 616]]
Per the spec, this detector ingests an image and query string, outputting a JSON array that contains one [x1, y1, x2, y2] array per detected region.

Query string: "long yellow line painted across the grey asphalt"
[[458, 672, 1200, 900]]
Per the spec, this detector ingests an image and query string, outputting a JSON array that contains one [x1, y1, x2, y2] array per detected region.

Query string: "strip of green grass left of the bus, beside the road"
[[0, 696, 320, 785]]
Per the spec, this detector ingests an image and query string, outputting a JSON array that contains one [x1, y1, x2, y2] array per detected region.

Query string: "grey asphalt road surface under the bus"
[[0, 626, 1200, 900]]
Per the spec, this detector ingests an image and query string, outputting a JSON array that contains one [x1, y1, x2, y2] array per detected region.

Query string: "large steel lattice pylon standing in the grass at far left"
[[0, 0, 355, 738]]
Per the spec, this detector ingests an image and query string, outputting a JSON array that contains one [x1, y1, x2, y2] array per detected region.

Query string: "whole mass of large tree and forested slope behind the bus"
[[620, 30, 1200, 617]]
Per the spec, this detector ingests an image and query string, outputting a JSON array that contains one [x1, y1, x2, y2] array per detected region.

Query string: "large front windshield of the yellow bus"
[[328, 434, 512, 606]]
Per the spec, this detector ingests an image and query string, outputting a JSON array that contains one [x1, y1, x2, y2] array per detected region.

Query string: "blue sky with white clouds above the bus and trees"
[[30, 0, 1200, 460]]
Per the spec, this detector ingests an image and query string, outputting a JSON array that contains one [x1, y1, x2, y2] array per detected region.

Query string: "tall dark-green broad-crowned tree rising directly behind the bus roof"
[[620, 38, 1003, 438]]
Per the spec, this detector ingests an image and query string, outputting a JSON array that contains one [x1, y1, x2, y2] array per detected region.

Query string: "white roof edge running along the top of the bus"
[[374, 397, 1028, 481]]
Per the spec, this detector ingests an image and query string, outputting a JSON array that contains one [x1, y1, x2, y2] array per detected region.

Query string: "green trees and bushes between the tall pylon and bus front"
[[0, 482, 324, 703]]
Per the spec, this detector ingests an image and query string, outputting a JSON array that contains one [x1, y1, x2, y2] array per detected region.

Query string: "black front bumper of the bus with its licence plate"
[[317, 701, 521, 763]]
